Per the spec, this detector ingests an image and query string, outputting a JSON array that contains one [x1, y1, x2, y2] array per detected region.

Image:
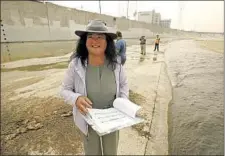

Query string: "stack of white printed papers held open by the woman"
[[84, 100, 144, 136]]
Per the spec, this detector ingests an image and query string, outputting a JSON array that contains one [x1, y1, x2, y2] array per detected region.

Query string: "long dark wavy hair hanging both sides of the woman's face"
[[70, 34, 117, 70]]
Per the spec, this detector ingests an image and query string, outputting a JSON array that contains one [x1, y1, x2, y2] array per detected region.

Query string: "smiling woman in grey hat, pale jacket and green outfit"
[[61, 20, 129, 155]]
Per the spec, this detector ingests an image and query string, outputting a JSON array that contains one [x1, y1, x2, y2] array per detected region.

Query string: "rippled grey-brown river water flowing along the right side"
[[165, 40, 224, 155]]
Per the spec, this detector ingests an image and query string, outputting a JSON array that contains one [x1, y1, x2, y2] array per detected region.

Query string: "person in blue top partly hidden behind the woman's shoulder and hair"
[[116, 31, 126, 65]]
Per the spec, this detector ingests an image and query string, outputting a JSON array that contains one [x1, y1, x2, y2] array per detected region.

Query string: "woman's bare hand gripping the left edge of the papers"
[[75, 96, 92, 115]]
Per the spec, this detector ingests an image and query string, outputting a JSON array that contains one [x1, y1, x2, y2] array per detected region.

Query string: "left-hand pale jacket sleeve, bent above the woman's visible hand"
[[60, 60, 81, 105]]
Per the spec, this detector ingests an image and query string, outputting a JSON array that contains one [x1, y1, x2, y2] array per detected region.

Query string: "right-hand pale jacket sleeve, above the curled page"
[[119, 65, 129, 99]]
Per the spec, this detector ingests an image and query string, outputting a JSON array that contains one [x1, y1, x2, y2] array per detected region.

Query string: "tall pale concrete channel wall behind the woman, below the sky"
[[1, 1, 186, 42]]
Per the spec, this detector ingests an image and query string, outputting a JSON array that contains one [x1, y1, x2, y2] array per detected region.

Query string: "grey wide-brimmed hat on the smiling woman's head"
[[75, 20, 117, 40]]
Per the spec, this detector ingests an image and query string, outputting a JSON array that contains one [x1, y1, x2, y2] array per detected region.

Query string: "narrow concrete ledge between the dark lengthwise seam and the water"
[[145, 63, 172, 155]]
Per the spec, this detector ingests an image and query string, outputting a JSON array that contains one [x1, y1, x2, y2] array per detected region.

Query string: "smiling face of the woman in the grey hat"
[[86, 33, 107, 55]]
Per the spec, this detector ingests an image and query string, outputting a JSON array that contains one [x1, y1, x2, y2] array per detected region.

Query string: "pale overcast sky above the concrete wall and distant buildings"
[[48, 1, 224, 32]]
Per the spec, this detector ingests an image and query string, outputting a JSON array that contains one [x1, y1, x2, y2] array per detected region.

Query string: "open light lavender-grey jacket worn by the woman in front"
[[60, 58, 129, 135]]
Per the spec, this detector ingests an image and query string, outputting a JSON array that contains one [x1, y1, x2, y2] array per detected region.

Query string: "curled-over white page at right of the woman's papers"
[[113, 98, 141, 118]]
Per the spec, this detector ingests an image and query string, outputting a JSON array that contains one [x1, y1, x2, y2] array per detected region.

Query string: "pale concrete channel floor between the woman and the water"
[[118, 46, 172, 155]]
